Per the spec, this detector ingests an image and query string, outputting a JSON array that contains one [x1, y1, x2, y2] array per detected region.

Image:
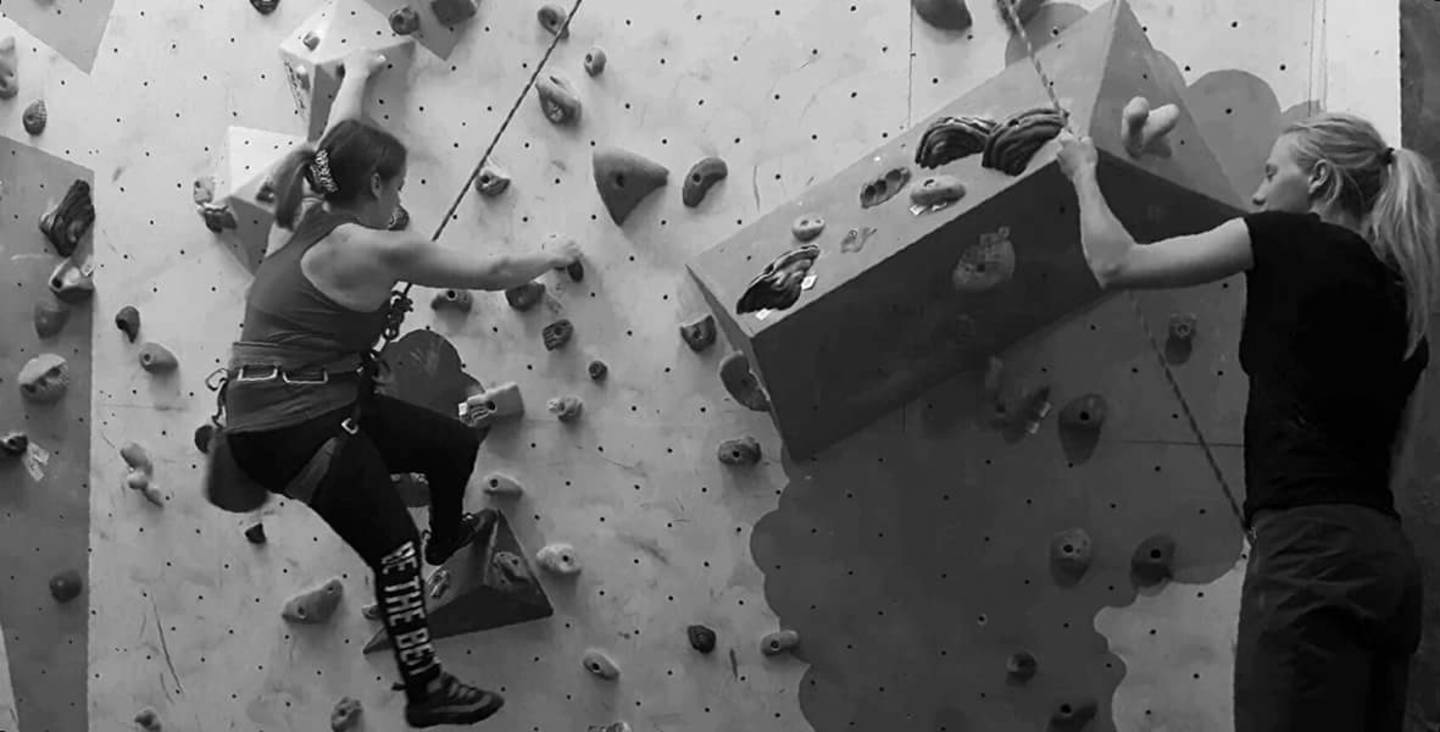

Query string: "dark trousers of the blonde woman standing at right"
[[1236, 504, 1421, 732]]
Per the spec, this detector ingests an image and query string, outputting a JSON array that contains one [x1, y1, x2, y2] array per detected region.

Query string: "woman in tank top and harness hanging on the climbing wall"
[[212, 52, 580, 728]]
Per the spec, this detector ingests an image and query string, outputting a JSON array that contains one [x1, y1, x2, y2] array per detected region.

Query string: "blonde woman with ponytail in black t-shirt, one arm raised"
[[1060, 114, 1440, 732]]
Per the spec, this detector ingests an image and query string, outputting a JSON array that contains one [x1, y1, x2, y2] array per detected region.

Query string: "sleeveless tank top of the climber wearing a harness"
[[225, 205, 387, 432]]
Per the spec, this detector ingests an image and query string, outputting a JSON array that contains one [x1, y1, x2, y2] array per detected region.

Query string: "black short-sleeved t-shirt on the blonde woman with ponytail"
[[1240, 212, 1430, 525]]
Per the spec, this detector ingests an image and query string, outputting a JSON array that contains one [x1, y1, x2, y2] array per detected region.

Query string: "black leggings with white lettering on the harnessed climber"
[[229, 395, 480, 699]]
